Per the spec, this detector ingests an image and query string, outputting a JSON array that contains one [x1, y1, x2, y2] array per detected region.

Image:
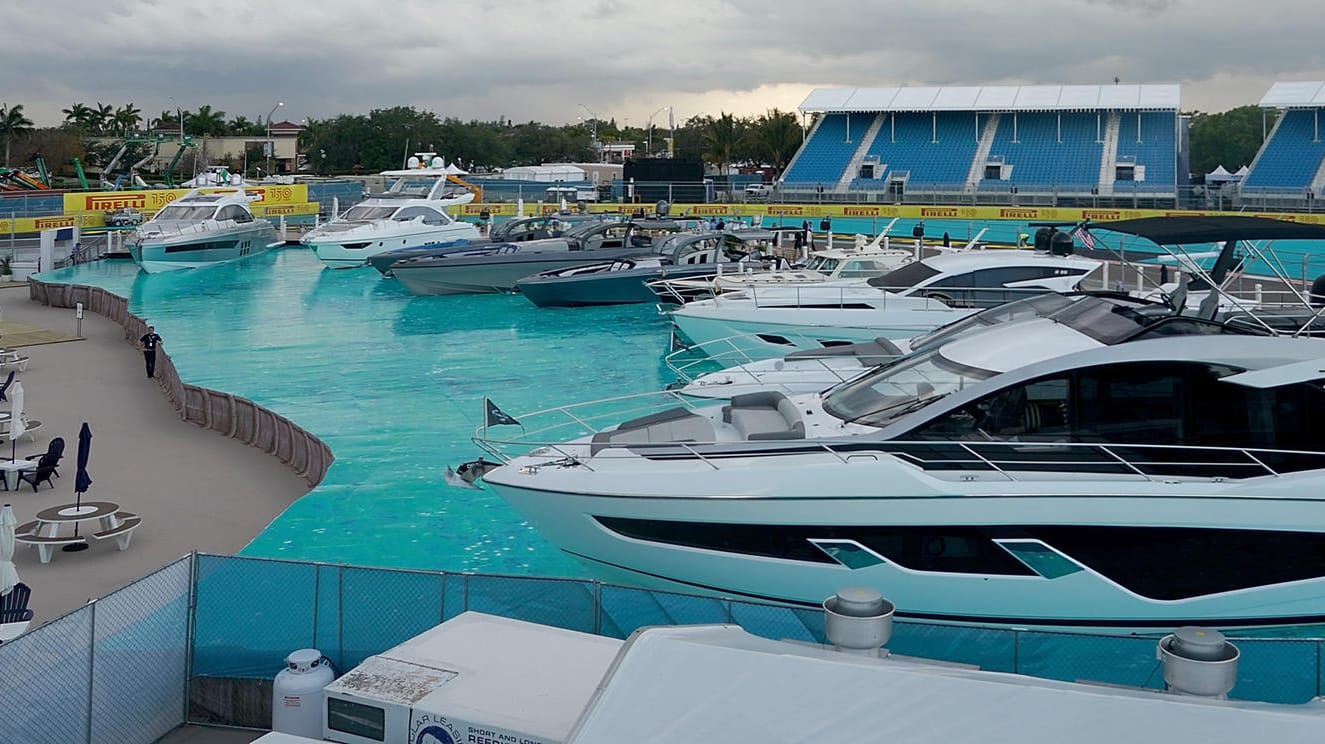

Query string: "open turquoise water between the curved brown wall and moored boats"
[[42, 248, 673, 576]]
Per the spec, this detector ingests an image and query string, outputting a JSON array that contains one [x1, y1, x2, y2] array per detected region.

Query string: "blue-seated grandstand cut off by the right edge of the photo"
[[1239, 81, 1325, 208]]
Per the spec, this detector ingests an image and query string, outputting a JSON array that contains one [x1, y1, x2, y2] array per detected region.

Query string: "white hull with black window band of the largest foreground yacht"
[[485, 454, 1325, 633]]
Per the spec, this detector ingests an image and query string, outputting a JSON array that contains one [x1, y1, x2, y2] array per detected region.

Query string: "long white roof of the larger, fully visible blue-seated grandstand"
[[799, 85, 1179, 113]]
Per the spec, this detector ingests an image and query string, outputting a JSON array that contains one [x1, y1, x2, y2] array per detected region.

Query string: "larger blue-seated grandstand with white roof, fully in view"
[[780, 85, 1187, 207]]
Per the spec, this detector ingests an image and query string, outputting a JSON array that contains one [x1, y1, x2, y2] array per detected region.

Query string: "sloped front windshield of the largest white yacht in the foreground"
[[824, 348, 994, 428]]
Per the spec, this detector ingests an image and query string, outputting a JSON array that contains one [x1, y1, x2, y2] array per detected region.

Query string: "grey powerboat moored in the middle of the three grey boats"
[[391, 220, 698, 295]]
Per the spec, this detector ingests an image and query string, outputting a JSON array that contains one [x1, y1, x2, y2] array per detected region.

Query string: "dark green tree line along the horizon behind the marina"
[[0, 102, 1273, 177]]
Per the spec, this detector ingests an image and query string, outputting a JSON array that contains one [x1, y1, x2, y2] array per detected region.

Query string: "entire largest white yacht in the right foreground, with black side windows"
[[476, 333, 1325, 631]]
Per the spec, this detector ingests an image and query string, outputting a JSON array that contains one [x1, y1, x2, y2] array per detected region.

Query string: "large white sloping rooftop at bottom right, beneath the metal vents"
[[568, 626, 1325, 744]]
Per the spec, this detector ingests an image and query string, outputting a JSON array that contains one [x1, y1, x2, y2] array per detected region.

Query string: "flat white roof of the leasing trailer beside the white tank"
[[327, 612, 621, 741]]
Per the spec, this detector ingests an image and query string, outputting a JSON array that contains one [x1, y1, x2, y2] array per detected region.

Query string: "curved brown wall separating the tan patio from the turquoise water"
[[28, 278, 335, 486]]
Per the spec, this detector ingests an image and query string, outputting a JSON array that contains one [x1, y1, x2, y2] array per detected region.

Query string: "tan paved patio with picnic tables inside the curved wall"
[[0, 286, 309, 625]]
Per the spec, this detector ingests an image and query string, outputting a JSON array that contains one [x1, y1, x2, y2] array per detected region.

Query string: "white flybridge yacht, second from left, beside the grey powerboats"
[[299, 158, 484, 269]]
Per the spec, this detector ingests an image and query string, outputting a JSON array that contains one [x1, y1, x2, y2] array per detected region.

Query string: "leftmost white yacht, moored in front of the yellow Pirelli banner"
[[129, 188, 281, 274]]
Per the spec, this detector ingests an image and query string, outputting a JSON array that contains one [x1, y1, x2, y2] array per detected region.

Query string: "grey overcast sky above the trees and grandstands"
[[0, 0, 1325, 127]]
